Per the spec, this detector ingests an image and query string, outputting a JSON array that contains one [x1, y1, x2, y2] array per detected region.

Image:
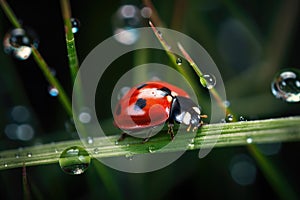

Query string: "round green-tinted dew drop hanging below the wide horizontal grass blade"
[[59, 146, 91, 175]]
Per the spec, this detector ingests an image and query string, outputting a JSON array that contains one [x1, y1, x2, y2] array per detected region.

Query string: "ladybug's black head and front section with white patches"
[[170, 96, 202, 131]]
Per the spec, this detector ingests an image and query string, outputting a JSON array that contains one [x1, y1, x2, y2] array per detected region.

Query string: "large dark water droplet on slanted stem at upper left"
[[3, 28, 39, 60]]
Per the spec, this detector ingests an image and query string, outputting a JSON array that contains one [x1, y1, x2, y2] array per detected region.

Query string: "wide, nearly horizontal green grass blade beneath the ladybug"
[[0, 116, 300, 170]]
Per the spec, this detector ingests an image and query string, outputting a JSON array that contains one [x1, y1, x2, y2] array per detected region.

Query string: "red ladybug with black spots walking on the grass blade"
[[114, 81, 207, 141]]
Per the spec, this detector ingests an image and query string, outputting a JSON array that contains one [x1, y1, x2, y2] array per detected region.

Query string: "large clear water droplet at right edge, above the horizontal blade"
[[271, 68, 300, 102]]
